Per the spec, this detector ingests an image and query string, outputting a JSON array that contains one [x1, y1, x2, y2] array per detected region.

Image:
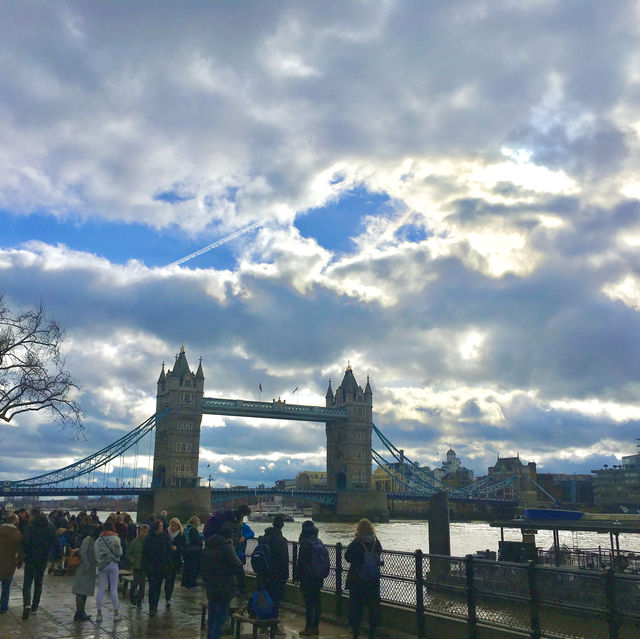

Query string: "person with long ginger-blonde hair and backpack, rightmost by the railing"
[[344, 519, 382, 639]]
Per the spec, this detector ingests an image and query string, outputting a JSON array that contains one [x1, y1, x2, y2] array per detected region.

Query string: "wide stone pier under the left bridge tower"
[[138, 486, 211, 523]]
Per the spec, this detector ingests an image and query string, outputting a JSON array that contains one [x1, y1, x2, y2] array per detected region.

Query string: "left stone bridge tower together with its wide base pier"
[[138, 344, 211, 521]]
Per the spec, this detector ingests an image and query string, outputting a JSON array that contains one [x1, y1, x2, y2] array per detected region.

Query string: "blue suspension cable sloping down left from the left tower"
[[9, 410, 169, 488]]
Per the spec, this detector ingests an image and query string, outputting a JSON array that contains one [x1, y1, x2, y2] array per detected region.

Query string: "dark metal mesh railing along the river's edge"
[[245, 539, 640, 639]]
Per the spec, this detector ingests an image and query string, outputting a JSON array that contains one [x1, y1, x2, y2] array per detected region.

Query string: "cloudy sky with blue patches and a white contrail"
[[0, 0, 640, 485]]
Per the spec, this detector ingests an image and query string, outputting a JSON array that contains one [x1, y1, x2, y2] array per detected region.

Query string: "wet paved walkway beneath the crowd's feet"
[[0, 570, 410, 639]]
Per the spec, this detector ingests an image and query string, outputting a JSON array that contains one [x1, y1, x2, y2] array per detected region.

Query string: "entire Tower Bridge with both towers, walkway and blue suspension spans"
[[0, 346, 515, 520]]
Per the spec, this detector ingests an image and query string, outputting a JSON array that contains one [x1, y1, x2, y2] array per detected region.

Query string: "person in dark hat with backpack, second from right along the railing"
[[296, 520, 330, 637]]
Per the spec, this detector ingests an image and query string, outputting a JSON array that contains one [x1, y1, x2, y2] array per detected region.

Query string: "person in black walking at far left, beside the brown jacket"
[[22, 508, 56, 619]]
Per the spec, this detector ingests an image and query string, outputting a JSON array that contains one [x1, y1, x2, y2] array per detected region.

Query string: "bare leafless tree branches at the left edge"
[[0, 293, 83, 435]]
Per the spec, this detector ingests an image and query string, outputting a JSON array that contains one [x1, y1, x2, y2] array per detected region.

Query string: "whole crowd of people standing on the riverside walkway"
[[0, 505, 382, 639]]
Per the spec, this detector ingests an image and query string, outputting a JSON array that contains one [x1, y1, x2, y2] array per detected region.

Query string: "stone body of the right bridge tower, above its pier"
[[326, 366, 373, 491]]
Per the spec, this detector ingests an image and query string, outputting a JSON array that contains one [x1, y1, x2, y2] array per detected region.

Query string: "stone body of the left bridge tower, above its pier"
[[152, 346, 204, 488]]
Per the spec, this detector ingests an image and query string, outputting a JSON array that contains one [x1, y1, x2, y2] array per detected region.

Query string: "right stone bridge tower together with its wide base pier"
[[322, 365, 389, 521]]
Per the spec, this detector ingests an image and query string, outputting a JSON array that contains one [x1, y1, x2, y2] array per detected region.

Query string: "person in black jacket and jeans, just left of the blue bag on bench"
[[200, 527, 244, 639]]
